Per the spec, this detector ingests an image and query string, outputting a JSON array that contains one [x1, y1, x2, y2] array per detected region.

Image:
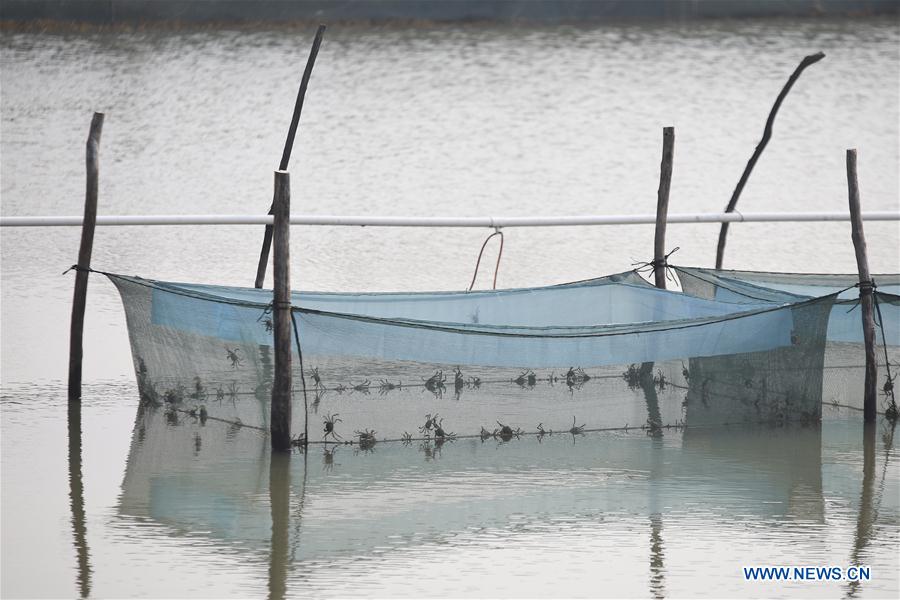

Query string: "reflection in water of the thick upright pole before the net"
[[269, 452, 292, 599]]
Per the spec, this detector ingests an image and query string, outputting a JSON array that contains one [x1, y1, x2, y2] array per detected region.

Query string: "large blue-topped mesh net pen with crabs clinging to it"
[[109, 274, 835, 442]]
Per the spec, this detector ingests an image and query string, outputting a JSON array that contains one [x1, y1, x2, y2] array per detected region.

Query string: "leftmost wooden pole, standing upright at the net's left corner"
[[69, 113, 103, 402]]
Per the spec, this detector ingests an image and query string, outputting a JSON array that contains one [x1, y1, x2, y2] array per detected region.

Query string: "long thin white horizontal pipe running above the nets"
[[0, 211, 900, 227]]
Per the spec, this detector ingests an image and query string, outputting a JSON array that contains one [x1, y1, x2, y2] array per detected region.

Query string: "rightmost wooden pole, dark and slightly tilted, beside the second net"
[[847, 150, 878, 423]]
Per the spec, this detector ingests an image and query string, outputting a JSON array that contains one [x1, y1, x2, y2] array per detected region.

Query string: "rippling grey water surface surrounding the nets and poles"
[[0, 16, 900, 597]]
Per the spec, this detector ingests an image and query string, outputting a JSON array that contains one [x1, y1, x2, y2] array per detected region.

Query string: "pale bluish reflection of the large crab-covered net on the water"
[[118, 400, 844, 598]]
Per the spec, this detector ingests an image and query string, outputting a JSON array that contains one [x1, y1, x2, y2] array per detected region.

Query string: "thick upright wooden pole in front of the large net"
[[269, 171, 292, 451]]
